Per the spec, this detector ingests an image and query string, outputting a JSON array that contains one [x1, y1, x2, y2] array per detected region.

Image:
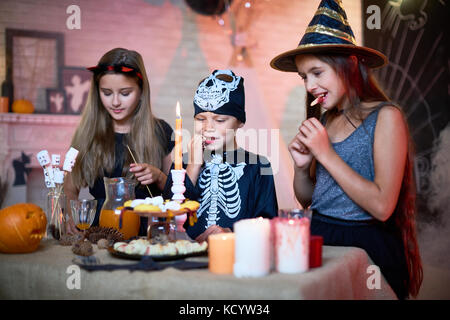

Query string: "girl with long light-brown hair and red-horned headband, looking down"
[[64, 48, 173, 234]]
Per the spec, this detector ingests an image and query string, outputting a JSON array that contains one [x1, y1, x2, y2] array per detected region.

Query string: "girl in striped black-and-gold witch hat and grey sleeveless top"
[[271, 0, 423, 299]]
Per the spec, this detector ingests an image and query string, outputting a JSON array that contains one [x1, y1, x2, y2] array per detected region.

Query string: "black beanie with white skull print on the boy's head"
[[194, 69, 245, 123]]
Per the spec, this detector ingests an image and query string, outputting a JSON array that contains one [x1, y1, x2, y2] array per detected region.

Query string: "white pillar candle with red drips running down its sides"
[[273, 218, 310, 273]]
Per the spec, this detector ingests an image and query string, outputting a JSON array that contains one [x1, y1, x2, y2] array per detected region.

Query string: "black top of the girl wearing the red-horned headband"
[[89, 119, 175, 231]]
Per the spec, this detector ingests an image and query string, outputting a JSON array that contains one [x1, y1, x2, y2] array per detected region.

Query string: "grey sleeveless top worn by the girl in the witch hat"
[[311, 102, 393, 221]]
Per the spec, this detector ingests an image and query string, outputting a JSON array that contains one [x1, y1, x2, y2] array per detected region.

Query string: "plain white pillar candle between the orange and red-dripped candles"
[[233, 218, 271, 277]]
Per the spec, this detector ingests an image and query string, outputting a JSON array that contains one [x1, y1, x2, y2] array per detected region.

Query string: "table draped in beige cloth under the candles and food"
[[0, 240, 396, 300]]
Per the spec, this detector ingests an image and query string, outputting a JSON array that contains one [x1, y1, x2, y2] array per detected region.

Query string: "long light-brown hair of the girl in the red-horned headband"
[[71, 48, 165, 188]]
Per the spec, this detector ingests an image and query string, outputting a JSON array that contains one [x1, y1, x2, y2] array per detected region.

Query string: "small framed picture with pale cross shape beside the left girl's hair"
[[62, 67, 92, 114]]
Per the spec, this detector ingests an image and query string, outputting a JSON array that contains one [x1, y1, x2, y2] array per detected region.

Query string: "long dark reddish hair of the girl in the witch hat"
[[306, 54, 423, 297]]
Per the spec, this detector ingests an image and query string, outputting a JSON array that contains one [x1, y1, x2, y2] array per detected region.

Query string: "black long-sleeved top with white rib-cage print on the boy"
[[164, 149, 278, 239]]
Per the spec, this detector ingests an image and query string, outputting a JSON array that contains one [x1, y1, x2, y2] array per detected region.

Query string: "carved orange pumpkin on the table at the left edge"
[[0, 203, 47, 253]]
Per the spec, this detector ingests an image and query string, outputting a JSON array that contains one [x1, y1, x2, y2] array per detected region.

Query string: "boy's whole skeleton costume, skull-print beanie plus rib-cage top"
[[164, 70, 278, 239]]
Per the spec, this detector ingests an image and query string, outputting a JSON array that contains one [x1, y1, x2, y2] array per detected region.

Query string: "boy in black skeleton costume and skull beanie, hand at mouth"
[[166, 70, 278, 241]]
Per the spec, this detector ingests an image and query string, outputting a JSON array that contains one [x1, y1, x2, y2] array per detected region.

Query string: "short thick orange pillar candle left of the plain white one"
[[208, 233, 234, 274]]
